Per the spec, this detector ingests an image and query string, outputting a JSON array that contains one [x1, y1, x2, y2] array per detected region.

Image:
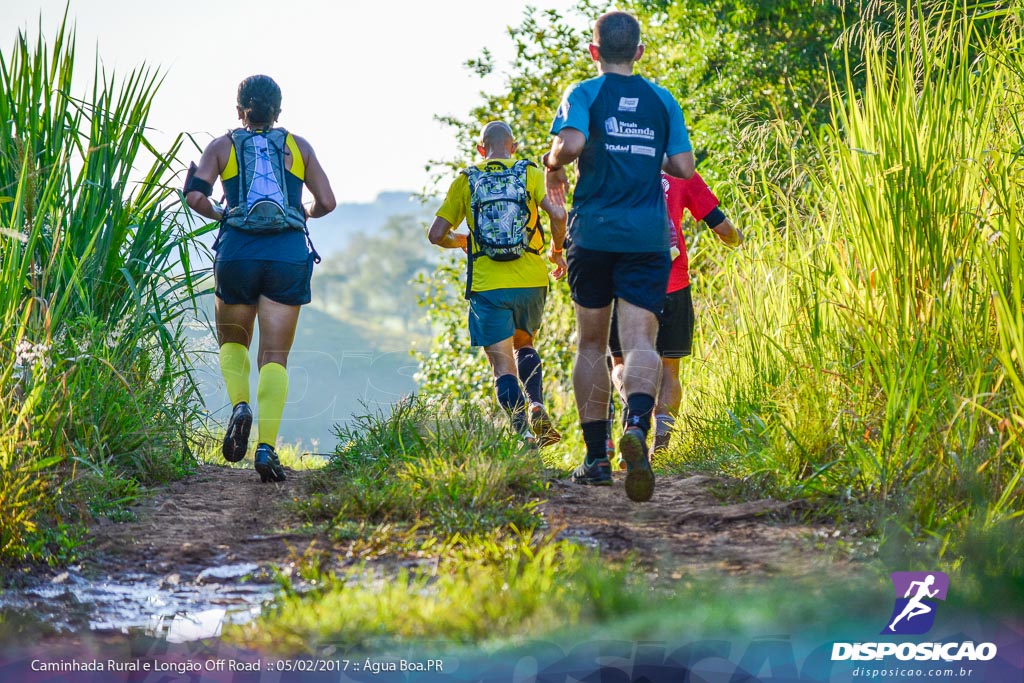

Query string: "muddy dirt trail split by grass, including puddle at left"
[[0, 458, 844, 643]]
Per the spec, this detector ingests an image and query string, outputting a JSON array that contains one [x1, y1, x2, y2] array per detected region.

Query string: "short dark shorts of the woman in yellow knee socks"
[[213, 255, 313, 306]]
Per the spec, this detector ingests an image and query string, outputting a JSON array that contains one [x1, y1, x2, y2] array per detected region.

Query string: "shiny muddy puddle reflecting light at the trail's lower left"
[[0, 562, 302, 643]]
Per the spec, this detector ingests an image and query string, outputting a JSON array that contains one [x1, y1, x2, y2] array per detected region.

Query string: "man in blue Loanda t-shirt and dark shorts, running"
[[544, 11, 694, 501]]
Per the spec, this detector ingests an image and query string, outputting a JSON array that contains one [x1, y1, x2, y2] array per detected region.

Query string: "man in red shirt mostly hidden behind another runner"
[[608, 173, 743, 452]]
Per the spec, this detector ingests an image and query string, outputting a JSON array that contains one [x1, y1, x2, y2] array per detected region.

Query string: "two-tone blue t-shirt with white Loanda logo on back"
[[551, 74, 693, 252]]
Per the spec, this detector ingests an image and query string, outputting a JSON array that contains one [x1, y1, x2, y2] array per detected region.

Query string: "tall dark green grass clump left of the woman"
[[0, 17, 207, 562]]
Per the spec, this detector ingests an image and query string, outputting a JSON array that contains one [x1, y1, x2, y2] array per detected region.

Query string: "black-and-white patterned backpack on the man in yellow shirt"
[[463, 159, 540, 261]]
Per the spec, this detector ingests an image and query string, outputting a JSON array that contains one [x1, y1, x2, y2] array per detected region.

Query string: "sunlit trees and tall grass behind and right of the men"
[[421, 1, 1024, 571]]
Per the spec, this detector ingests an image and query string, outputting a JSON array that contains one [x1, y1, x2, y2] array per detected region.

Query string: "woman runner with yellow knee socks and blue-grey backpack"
[[184, 75, 336, 481]]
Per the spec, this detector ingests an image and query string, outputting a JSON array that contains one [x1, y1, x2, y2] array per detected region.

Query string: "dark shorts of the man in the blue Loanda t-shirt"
[[565, 244, 672, 315]]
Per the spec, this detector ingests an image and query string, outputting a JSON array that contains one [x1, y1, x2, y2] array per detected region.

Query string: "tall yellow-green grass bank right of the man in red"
[[677, 2, 1024, 559]]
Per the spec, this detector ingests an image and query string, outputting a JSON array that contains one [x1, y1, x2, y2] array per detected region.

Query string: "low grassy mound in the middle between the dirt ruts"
[[298, 398, 545, 537]]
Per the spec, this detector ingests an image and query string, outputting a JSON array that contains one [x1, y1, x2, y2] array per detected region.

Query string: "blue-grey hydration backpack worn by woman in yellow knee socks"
[[223, 128, 306, 232]]
